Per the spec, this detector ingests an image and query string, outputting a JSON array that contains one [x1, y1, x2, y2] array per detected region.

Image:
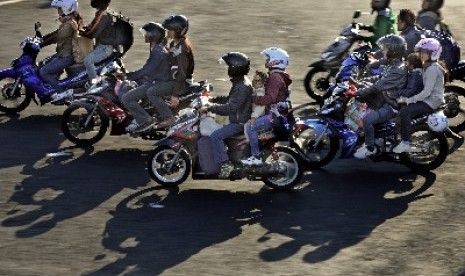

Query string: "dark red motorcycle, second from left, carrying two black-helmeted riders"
[[61, 61, 213, 146]]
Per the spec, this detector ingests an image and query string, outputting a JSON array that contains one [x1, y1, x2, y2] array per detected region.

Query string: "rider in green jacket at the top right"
[[359, 0, 397, 46]]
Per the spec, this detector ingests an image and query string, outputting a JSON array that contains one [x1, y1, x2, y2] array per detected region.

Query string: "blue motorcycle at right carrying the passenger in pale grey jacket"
[[293, 82, 449, 172]]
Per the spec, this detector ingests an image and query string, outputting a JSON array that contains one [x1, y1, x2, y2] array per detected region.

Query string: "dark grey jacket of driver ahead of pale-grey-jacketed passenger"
[[356, 60, 407, 110]]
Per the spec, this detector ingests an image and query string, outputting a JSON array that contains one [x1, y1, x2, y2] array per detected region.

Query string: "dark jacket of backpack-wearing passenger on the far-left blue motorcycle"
[[79, 10, 115, 45]]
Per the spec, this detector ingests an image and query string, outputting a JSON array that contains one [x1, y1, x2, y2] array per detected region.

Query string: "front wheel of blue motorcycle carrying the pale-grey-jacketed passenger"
[[294, 123, 339, 169]]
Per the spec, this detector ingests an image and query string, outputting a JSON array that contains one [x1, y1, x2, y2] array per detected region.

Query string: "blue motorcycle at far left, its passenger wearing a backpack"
[[0, 22, 121, 114]]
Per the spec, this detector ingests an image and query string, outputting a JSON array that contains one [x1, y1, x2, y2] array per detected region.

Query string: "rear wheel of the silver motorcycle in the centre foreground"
[[263, 147, 304, 190]]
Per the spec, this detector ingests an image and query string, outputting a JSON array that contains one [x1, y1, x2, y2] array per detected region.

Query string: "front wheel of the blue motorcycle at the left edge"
[[0, 78, 32, 114]]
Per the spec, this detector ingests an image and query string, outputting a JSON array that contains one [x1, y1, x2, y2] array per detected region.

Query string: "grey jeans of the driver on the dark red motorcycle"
[[121, 84, 152, 125]]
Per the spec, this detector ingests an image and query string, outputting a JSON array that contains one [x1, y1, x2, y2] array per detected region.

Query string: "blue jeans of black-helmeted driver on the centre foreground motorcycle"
[[210, 123, 244, 164]]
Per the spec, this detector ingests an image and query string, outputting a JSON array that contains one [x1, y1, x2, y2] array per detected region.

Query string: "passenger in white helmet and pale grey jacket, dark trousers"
[[393, 38, 444, 153]]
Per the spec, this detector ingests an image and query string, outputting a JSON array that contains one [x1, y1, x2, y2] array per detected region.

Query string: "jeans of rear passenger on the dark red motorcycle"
[[147, 81, 174, 122]]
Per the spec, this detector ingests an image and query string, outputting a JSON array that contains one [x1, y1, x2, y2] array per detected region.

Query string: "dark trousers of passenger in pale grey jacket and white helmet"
[[399, 102, 434, 141]]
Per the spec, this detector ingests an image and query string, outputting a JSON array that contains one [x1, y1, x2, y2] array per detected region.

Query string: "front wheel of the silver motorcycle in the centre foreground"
[[147, 146, 191, 187]]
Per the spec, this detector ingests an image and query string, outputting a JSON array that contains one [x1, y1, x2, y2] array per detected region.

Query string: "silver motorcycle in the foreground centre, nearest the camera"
[[147, 98, 303, 189]]
